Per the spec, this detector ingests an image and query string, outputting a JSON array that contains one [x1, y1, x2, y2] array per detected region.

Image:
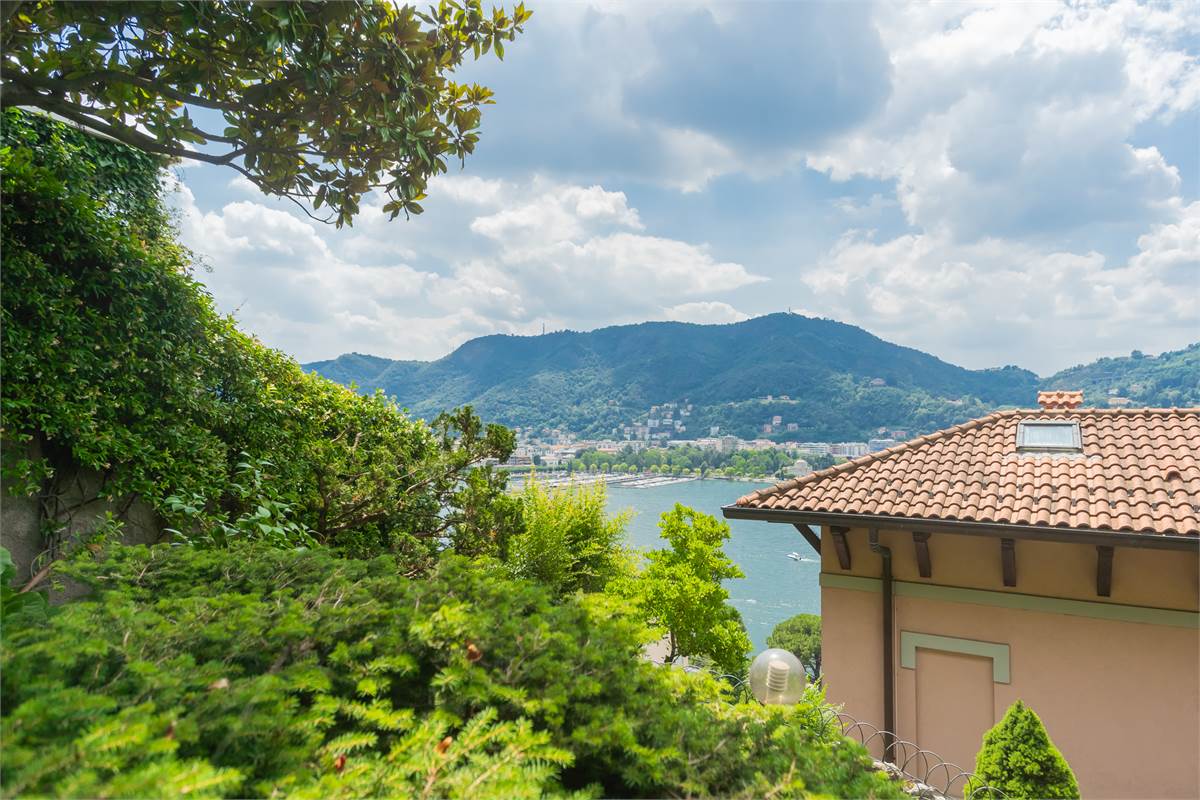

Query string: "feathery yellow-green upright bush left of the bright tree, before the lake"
[[508, 480, 630, 594]]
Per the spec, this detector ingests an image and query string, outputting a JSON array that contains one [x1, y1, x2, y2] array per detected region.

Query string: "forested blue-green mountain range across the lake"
[[304, 313, 1200, 441]]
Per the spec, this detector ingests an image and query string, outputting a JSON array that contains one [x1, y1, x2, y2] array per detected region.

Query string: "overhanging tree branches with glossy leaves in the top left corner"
[[0, 0, 530, 225]]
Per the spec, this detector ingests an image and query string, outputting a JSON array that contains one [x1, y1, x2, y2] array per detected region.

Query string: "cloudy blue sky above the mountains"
[[172, 0, 1200, 374]]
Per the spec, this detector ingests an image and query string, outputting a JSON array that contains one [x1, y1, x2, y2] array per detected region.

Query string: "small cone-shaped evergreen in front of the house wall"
[[966, 700, 1079, 799]]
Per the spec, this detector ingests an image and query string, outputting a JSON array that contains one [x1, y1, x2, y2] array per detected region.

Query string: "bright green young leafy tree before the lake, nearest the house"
[[625, 503, 750, 674]]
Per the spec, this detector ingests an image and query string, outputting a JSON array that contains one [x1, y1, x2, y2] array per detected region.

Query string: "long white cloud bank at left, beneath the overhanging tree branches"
[[178, 178, 764, 360]]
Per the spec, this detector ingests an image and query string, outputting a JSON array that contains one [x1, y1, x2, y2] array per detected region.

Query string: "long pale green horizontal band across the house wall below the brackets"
[[821, 572, 1200, 630]]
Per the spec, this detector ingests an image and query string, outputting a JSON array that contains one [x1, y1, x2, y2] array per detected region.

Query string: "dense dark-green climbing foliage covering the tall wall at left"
[[0, 112, 515, 570]]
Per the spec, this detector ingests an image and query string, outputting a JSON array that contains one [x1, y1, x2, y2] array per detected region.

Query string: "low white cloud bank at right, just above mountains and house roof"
[[803, 203, 1200, 372]]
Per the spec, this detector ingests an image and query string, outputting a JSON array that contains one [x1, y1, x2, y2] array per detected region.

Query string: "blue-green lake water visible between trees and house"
[[608, 481, 821, 652]]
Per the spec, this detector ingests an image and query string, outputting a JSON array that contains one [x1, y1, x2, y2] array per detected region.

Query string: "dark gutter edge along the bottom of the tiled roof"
[[721, 504, 1200, 552]]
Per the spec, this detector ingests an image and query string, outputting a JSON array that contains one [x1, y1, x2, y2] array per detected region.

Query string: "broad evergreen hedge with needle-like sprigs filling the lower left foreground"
[[0, 545, 901, 798]]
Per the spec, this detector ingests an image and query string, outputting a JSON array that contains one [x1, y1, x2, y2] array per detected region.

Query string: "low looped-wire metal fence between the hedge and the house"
[[667, 666, 1008, 800]]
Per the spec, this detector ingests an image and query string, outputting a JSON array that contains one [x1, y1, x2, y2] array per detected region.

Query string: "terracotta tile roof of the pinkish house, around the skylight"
[[737, 409, 1200, 535]]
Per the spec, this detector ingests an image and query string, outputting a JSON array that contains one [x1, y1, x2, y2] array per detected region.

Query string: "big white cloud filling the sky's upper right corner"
[[806, 2, 1200, 241]]
